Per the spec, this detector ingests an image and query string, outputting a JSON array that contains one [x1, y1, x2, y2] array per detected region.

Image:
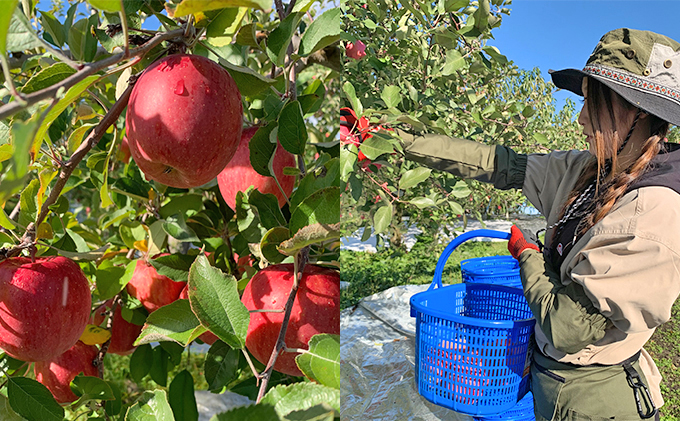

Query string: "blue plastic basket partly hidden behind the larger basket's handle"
[[460, 256, 522, 288]]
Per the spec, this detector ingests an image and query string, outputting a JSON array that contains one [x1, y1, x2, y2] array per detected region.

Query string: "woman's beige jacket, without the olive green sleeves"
[[523, 151, 680, 406]]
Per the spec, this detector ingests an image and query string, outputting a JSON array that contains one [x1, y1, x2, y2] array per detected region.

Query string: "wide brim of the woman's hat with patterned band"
[[548, 69, 680, 126]]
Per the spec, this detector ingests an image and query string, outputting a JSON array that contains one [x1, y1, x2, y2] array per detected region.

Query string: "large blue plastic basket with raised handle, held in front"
[[410, 230, 535, 415]]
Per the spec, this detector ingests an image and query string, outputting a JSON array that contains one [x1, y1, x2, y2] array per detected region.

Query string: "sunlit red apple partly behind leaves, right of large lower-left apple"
[[126, 253, 187, 313]]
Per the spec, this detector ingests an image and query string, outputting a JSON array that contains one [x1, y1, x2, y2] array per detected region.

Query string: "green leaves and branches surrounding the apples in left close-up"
[[0, 0, 341, 420]]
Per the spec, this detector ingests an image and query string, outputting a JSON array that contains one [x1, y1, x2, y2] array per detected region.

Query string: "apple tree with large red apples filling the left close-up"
[[0, 0, 342, 421]]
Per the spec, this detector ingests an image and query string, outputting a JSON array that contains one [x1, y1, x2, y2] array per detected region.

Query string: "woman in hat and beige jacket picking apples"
[[400, 29, 680, 420]]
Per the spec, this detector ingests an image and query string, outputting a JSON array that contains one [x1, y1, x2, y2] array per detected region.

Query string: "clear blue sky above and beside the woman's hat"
[[488, 0, 680, 107]]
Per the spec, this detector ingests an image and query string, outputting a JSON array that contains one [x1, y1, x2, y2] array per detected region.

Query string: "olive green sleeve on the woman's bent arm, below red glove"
[[519, 250, 613, 354]]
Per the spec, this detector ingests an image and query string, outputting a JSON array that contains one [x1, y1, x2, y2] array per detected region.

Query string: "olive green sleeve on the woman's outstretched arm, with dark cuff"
[[397, 130, 527, 190]]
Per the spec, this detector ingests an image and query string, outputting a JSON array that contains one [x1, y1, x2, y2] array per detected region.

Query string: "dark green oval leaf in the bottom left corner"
[[7, 377, 64, 421]]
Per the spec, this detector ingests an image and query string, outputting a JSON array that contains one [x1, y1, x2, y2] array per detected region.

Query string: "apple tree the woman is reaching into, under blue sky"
[[341, 0, 580, 247]]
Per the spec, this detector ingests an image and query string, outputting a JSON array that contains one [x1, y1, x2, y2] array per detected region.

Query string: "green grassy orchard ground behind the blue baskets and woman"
[[340, 217, 680, 421]]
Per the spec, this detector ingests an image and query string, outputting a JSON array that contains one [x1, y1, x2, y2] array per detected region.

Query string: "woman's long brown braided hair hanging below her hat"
[[560, 78, 669, 236]]
